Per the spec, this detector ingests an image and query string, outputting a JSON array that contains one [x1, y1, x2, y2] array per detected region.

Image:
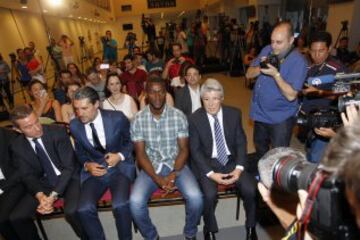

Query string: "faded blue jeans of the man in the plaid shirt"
[[130, 165, 203, 240]]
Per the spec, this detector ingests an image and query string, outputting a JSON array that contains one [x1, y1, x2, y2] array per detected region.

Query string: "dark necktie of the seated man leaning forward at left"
[[33, 138, 58, 187]]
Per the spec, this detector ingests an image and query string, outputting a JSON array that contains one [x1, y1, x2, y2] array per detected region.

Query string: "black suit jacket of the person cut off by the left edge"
[[0, 128, 21, 192]]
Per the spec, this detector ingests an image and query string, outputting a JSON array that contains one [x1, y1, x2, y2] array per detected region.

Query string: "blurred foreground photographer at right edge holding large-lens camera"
[[259, 106, 360, 239]]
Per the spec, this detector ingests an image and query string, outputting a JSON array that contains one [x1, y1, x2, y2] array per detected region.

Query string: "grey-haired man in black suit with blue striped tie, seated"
[[189, 79, 257, 240]]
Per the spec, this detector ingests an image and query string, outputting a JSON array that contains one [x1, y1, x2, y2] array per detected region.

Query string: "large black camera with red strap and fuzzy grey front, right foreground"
[[258, 147, 360, 240]]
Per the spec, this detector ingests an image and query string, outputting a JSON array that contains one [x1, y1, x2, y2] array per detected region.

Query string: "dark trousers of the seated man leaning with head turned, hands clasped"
[[10, 179, 86, 240]]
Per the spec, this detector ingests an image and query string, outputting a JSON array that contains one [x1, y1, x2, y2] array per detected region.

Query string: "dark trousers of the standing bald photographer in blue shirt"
[[254, 117, 295, 158]]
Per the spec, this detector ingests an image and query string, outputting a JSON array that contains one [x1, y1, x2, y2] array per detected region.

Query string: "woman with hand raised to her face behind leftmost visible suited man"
[[28, 80, 62, 122]]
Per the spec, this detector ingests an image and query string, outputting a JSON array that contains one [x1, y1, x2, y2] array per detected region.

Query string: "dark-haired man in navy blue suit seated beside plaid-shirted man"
[[70, 87, 135, 240]]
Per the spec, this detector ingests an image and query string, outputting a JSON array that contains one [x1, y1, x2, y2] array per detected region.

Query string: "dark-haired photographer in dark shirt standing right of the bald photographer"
[[301, 31, 346, 163]]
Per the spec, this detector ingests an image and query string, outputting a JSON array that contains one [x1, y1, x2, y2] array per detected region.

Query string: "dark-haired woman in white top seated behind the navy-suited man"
[[102, 74, 138, 120]]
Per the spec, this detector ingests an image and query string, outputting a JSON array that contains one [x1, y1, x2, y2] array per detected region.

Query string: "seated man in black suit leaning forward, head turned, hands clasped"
[[10, 105, 86, 240]]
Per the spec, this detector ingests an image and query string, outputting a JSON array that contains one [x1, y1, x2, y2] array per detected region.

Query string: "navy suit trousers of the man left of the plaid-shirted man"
[[78, 172, 132, 240]]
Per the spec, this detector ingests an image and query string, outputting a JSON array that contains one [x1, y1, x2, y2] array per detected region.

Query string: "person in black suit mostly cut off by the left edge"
[[0, 128, 26, 240]]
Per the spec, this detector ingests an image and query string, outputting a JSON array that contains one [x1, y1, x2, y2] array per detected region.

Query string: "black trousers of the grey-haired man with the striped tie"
[[199, 159, 256, 232]]
